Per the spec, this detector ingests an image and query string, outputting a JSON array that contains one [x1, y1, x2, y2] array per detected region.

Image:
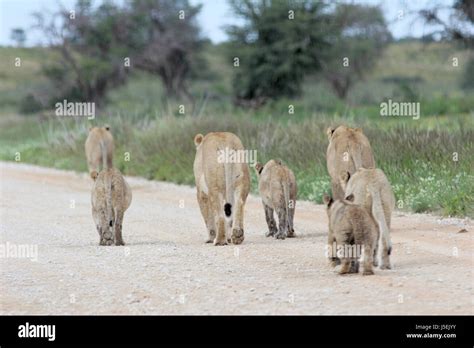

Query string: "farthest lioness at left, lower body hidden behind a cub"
[[84, 126, 114, 176]]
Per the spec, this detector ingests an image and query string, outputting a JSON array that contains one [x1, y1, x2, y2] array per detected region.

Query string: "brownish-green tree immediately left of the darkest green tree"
[[128, 0, 205, 99]]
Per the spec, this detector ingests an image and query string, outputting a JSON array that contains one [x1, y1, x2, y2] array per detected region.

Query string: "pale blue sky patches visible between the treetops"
[[0, 0, 460, 46]]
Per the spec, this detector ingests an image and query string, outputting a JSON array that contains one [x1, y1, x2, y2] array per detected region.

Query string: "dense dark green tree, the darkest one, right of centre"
[[227, 0, 328, 105]]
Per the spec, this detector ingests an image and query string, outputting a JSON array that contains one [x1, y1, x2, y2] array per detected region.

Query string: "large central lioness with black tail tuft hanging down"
[[194, 132, 250, 245]]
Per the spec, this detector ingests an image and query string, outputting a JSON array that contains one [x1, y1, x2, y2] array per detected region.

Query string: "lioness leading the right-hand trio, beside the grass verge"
[[326, 126, 375, 200]]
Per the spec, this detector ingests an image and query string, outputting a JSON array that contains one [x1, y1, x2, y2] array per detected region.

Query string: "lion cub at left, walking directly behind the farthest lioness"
[[91, 168, 132, 245]]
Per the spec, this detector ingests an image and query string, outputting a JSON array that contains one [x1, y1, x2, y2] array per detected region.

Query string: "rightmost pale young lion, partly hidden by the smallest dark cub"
[[340, 168, 395, 269]]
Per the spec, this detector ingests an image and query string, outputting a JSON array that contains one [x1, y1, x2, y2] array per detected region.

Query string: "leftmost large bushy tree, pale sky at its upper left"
[[34, 0, 129, 105]]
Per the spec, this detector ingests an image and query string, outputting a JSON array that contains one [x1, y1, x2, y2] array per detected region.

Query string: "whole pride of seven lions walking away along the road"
[[85, 126, 395, 275]]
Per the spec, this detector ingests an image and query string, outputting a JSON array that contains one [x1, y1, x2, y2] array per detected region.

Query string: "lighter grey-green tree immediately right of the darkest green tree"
[[322, 3, 391, 99]]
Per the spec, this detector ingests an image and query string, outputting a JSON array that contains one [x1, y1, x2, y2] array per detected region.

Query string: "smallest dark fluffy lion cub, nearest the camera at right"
[[323, 195, 378, 275]]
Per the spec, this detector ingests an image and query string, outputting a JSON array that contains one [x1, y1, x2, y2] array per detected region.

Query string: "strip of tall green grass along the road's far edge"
[[0, 114, 474, 217]]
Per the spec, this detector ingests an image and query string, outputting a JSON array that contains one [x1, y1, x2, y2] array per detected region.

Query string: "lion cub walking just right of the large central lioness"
[[254, 160, 297, 239]]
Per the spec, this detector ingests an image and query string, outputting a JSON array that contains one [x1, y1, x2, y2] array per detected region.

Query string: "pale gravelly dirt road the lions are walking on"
[[0, 163, 474, 314]]
